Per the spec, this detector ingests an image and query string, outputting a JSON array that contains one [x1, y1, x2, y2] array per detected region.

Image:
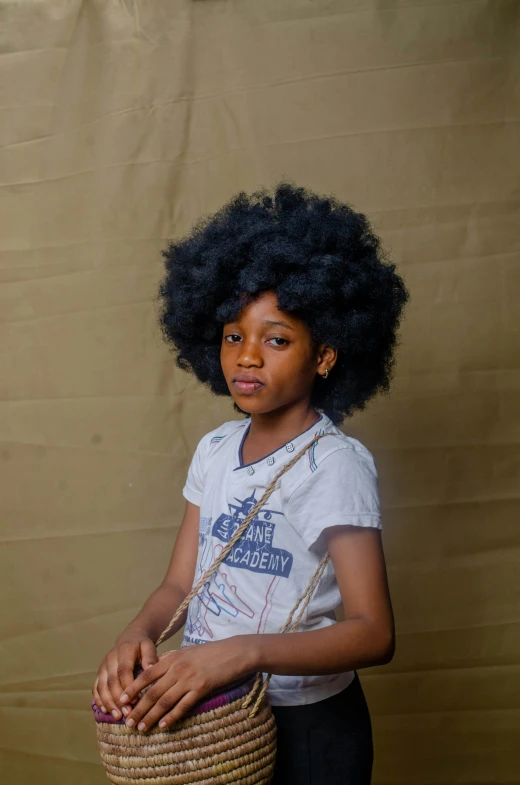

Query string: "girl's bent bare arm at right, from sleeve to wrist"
[[248, 526, 395, 676]]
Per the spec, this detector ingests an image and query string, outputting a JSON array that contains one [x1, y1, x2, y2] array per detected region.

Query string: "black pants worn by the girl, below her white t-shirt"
[[272, 673, 373, 785]]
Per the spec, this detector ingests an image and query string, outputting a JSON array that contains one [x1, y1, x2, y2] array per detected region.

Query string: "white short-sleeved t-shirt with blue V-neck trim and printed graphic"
[[182, 414, 381, 706]]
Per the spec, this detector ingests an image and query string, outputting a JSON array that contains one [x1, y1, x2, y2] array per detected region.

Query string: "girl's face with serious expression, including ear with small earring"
[[220, 292, 336, 414]]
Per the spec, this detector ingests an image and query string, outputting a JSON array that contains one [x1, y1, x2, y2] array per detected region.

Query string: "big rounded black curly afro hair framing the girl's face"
[[159, 181, 409, 424]]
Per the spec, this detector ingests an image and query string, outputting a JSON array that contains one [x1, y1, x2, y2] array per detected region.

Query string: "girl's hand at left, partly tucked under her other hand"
[[92, 630, 157, 720]]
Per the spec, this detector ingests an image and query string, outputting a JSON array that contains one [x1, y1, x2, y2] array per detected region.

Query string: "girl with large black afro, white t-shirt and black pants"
[[93, 183, 408, 785]]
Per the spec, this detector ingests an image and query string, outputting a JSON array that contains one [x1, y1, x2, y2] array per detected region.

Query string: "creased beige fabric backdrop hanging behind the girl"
[[0, 0, 520, 785]]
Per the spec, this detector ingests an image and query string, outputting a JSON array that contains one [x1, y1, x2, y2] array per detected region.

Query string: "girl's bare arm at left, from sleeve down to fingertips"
[[92, 502, 200, 719]]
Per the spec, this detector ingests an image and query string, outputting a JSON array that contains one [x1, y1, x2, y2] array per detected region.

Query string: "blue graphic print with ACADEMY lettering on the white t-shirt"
[[182, 492, 293, 646]]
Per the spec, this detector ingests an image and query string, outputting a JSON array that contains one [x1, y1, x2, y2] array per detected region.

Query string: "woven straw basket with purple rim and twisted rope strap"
[[93, 433, 329, 785]]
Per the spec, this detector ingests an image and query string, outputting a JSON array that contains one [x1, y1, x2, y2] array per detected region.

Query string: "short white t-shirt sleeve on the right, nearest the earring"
[[284, 447, 382, 549]]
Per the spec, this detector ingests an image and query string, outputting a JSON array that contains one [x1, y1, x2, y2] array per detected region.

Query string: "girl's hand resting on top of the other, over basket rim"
[[120, 635, 255, 731]]
